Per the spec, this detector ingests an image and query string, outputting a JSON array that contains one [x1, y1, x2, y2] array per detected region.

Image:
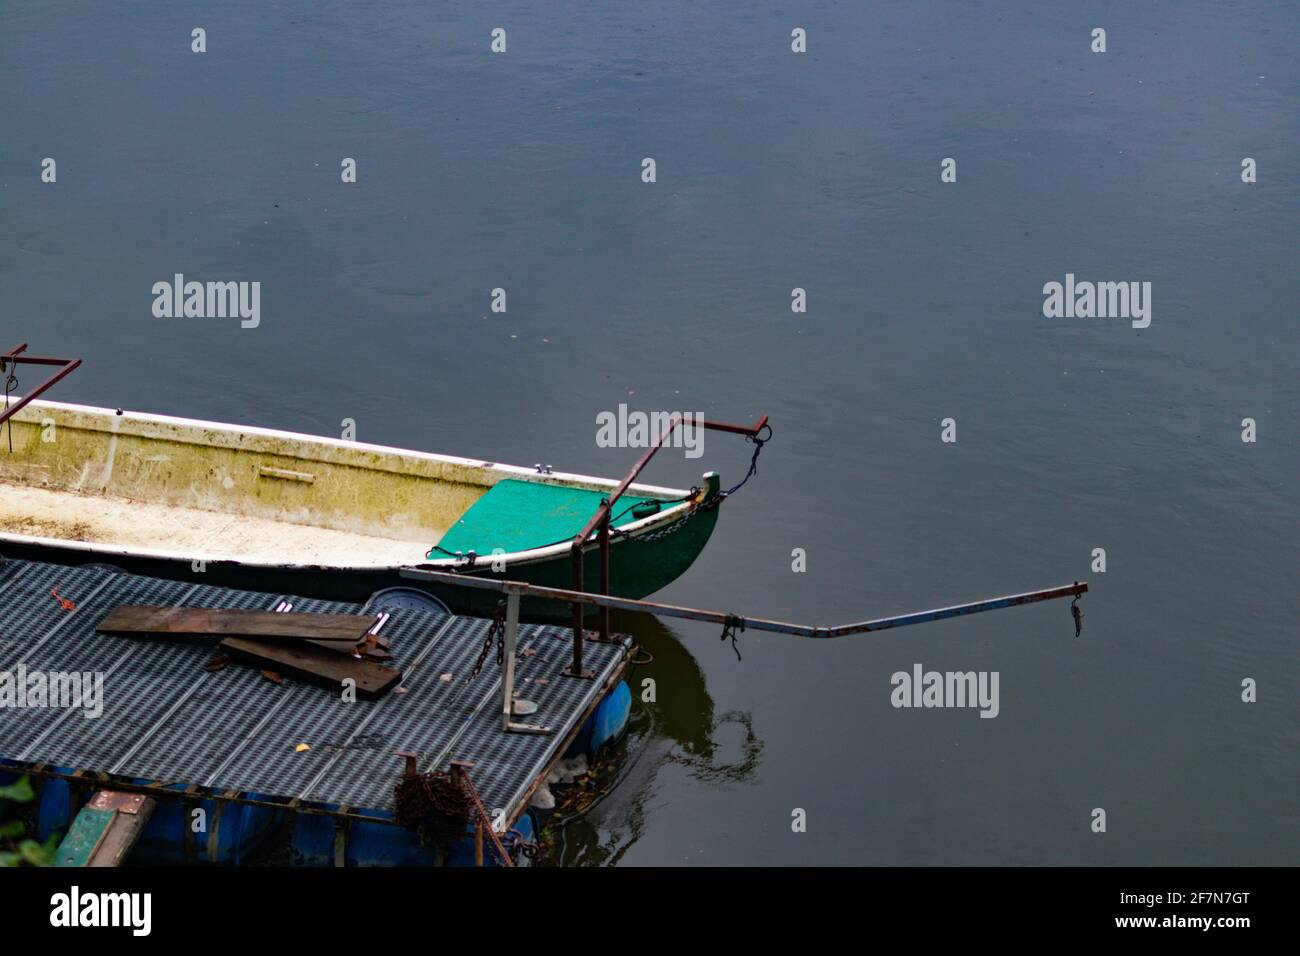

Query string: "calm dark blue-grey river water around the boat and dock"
[[0, 0, 1300, 865]]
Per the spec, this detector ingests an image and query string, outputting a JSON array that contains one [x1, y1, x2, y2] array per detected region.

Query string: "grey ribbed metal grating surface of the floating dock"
[[0, 561, 628, 817]]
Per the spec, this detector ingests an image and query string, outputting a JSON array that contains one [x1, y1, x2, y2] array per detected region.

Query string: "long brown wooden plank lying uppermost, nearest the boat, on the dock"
[[95, 605, 374, 644]]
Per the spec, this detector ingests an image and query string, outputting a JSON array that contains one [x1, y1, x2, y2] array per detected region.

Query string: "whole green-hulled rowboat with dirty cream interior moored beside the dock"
[[0, 401, 724, 614]]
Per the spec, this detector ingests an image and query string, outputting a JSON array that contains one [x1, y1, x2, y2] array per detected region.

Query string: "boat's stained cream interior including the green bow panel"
[[0, 402, 684, 567]]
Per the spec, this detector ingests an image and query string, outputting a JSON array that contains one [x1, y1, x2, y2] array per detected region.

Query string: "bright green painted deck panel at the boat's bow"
[[434, 479, 651, 557]]
